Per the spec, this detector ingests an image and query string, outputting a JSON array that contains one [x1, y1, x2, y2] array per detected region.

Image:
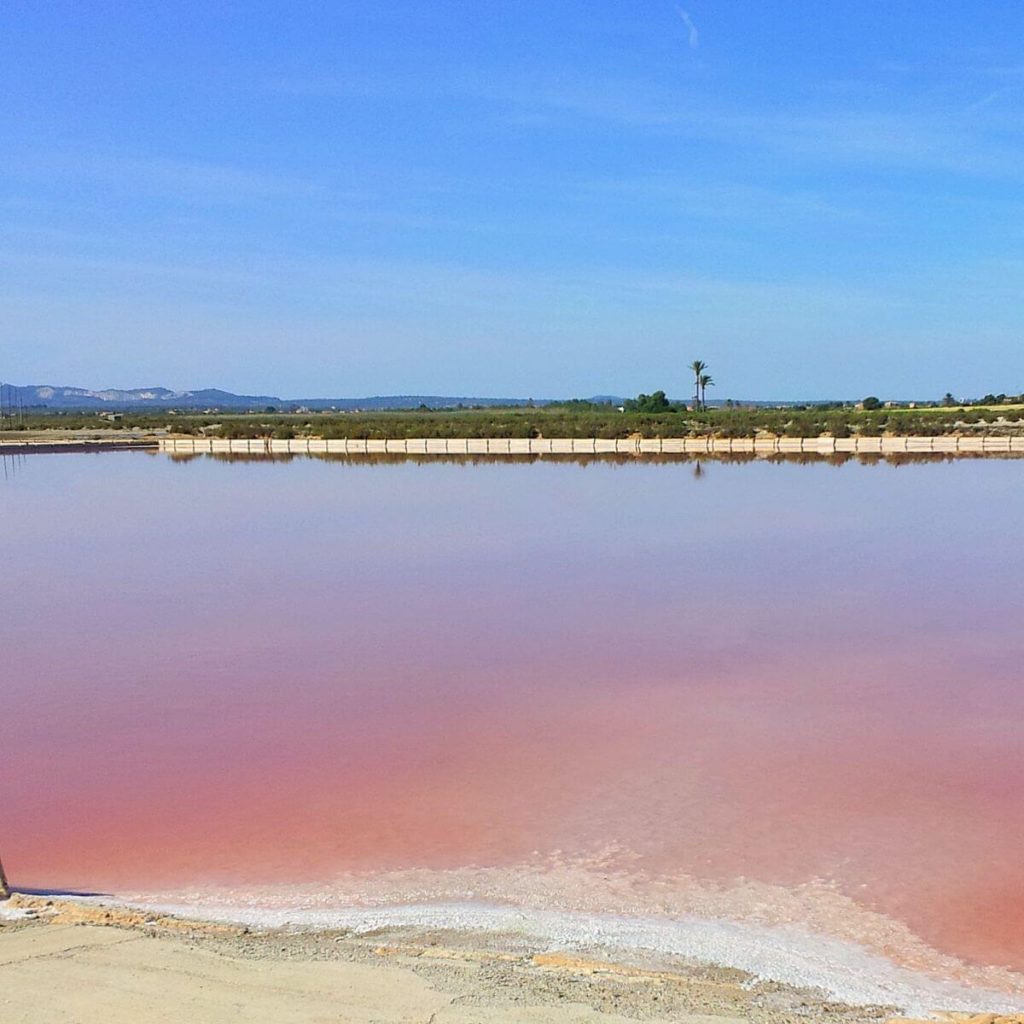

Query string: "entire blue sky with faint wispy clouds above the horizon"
[[0, 0, 1024, 398]]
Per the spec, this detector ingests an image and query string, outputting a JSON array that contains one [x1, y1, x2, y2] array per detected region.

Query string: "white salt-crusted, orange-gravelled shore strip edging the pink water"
[[0, 892, 1024, 1021]]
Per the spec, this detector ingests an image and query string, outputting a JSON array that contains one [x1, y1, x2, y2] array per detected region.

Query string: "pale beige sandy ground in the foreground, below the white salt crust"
[[0, 896, 1022, 1024]]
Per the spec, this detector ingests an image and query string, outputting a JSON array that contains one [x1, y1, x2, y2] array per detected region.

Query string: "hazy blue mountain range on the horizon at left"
[[0, 384, 585, 412]]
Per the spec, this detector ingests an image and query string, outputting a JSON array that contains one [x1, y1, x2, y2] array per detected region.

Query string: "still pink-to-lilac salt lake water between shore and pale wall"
[[0, 454, 1024, 969]]
